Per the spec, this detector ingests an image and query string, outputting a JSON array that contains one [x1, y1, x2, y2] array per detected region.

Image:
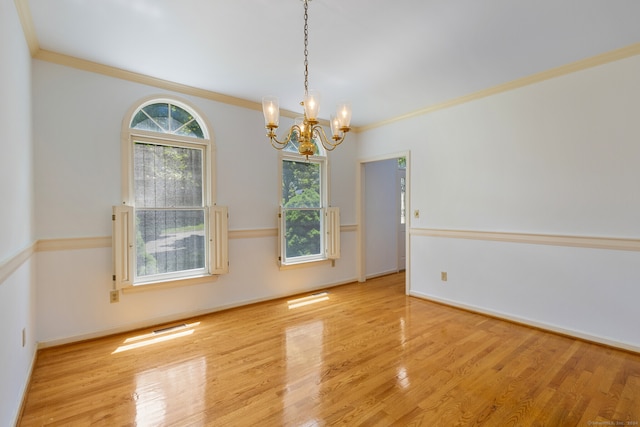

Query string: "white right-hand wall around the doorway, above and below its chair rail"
[[359, 57, 640, 349]]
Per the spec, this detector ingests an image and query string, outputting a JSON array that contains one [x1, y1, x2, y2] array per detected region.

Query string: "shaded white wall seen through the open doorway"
[[363, 159, 400, 277]]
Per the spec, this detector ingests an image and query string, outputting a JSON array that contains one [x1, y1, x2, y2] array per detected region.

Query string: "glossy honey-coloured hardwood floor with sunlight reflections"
[[20, 274, 640, 426]]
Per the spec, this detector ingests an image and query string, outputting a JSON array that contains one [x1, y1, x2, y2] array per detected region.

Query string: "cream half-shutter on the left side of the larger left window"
[[111, 205, 135, 289]]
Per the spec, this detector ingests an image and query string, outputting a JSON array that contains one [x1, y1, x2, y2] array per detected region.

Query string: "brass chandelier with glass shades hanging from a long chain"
[[262, 0, 351, 159]]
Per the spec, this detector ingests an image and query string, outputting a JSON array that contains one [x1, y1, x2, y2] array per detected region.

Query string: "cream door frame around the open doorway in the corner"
[[356, 150, 411, 295]]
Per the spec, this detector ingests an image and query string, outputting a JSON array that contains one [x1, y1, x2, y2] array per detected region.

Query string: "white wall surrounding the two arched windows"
[[33, 61, 356, 343]]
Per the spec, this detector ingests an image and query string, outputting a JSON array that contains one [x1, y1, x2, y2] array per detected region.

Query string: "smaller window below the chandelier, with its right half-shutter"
[[279, 137, 340, 265]]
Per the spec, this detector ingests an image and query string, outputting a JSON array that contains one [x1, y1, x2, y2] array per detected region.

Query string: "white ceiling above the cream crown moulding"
[[24, 0, 640, 126]]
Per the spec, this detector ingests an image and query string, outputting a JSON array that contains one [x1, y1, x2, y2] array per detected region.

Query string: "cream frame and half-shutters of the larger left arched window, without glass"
[[112, 96, 228, 289]]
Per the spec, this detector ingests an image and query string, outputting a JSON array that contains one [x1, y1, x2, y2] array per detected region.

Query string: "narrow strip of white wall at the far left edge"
[[0, 0, 35, 426]]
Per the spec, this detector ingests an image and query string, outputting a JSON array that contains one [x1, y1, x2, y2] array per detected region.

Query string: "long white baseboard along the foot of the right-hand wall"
[[409, 291, 640, 353]]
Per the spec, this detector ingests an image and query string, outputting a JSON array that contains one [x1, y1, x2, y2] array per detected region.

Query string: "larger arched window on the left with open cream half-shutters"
[[114, 99, 228, 287]]
